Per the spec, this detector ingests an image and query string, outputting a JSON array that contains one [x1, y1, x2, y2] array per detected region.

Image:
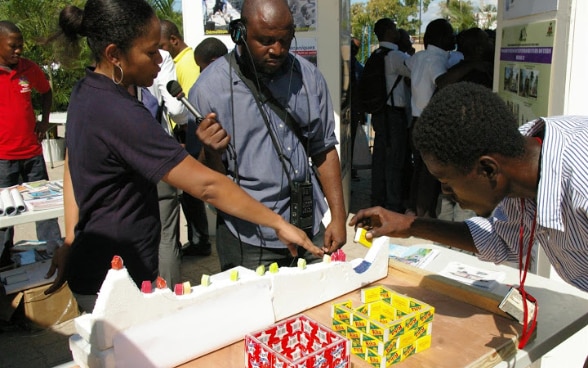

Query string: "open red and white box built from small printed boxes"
[[245, 315, 351, 368]]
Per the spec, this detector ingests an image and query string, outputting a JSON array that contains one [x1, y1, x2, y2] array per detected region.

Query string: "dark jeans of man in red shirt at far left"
[[0, 155, 61, 266]]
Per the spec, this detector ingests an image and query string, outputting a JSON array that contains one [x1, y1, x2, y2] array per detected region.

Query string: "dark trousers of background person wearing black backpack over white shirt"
[[372, 106, 408, 212]]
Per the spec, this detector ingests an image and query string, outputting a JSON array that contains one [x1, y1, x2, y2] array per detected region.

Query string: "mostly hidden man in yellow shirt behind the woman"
[[159, 20, 211, 256]]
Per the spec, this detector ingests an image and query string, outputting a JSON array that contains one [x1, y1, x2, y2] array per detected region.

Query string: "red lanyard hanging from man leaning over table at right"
[[518, 198, 539, 349]]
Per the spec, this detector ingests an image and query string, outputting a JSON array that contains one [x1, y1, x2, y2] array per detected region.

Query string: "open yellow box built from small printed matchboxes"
[[332, 286, 435, 368]]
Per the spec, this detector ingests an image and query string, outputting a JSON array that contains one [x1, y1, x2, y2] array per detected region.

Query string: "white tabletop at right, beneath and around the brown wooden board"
[[406, 241, 588, 368]]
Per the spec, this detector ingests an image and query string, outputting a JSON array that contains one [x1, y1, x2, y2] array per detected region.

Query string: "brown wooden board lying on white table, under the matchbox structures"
[[182, 264, 520, 368]]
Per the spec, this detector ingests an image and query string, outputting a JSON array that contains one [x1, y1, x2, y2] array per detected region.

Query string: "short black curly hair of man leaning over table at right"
[[413, 82, 525, 173]]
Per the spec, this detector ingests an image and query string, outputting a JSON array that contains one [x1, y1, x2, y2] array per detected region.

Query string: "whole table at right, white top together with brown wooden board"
[[182, 239, 588, 368]]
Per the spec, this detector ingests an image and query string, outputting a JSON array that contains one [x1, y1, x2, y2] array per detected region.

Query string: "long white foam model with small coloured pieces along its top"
[[70, 237, 388, 368]]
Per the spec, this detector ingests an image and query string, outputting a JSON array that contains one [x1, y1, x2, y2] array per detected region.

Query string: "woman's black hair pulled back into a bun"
[[59, 0, 155, 62]]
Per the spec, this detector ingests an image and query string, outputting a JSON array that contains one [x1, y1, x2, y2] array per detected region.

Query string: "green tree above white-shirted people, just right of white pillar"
[[351, 0, 431, 62]]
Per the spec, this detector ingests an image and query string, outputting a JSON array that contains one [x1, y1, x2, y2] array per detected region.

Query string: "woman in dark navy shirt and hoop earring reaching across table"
[[45, 0, 324, 311]]
